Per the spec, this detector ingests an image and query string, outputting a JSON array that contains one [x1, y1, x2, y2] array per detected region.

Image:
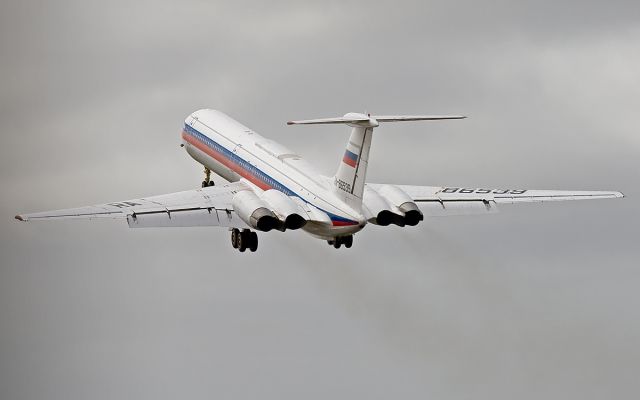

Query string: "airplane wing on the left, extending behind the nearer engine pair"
[[16, 182, 249, 228]]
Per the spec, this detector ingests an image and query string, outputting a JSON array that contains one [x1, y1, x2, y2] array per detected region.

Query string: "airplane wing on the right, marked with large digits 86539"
[[367, 183, 624, 216]]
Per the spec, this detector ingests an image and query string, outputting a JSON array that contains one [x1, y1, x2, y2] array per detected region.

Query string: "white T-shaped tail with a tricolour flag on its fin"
[[287, 113, 465, 209]]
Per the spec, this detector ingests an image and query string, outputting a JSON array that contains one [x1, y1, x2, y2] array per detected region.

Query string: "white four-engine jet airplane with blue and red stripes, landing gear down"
[[15, 109, 624, 252]]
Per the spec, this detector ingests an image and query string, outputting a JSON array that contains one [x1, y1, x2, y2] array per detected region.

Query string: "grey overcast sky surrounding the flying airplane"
[[0, 0, 640, 400]]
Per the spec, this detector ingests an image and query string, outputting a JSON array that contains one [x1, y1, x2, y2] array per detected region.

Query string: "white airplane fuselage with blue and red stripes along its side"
[[182, 110, 366, 239]]
